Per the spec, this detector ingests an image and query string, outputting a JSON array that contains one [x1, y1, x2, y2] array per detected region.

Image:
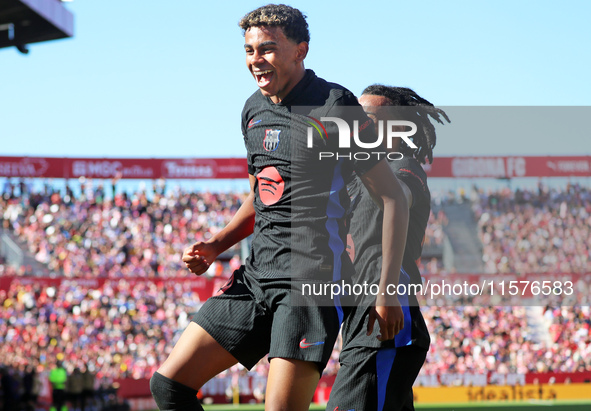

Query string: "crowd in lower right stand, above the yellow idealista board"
[[421, 306, 591, 375]]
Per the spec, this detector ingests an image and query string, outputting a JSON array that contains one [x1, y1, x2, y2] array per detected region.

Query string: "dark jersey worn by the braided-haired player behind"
[[343, 156, 431, 348]]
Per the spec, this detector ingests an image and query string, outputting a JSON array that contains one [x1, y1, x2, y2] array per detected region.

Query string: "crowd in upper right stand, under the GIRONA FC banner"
[[473, 183, 591, 273]]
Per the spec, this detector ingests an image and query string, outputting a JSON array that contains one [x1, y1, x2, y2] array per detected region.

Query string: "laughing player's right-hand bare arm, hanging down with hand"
[[361, 161, 409, 341]]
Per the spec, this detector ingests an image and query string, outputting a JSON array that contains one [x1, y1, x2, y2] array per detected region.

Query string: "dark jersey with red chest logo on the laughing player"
[[242, 70, 378, 280]]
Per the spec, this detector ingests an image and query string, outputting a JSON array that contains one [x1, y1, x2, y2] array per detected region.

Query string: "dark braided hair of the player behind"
[[362, 84, 450, 164]]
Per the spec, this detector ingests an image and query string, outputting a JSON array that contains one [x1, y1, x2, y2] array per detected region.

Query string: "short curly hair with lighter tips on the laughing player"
[[238, 4, 310, 44]]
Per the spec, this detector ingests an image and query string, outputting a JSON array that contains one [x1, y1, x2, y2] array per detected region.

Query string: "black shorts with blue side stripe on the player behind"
[[326, 345, 428, 411]]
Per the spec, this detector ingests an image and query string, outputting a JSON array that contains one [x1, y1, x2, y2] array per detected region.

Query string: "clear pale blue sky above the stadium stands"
[[0, 0, 591, 157]]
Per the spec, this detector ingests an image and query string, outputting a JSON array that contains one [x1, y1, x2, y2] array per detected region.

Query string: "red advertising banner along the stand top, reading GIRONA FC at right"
[[0, 156, 591, 179]]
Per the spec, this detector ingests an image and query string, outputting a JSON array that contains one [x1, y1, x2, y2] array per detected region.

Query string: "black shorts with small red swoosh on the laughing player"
[[193, 267, 342, 373]]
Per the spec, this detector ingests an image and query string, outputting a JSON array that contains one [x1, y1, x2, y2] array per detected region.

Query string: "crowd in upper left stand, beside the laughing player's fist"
[[0, 181, 246, 278]]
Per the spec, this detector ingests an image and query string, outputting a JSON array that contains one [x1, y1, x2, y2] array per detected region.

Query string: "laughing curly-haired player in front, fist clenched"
[[150, 5, 408, 410]]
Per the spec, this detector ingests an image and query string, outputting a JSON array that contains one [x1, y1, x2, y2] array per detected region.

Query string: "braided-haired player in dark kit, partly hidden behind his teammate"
[[327, 84, 449, 411]]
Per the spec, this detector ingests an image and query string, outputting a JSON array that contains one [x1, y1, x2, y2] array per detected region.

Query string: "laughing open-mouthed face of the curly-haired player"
[[244, 26, 308, 103]]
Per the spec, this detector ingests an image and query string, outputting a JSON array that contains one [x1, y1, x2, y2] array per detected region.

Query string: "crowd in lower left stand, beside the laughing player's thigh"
[[0, 280, 201, 378]]
